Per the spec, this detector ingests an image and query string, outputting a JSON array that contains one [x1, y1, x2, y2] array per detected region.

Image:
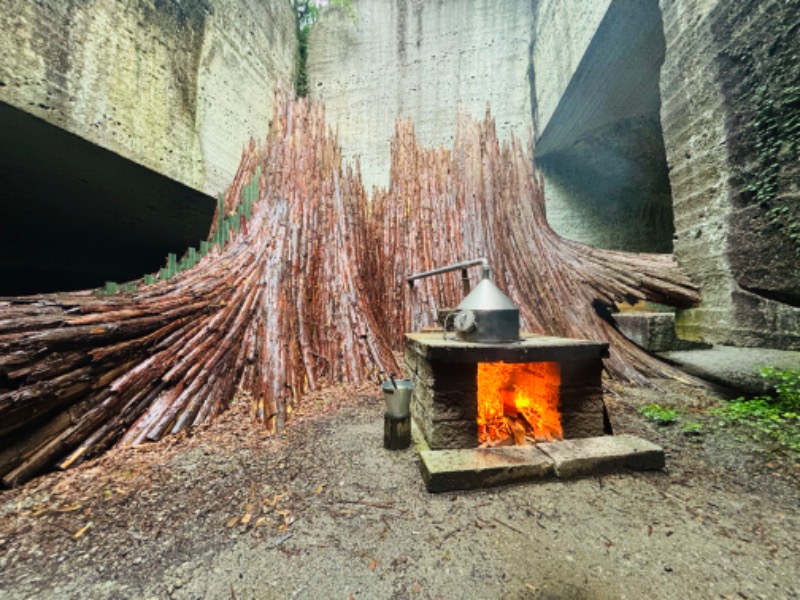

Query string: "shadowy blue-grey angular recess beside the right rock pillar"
[[536, 0, 674, 252]]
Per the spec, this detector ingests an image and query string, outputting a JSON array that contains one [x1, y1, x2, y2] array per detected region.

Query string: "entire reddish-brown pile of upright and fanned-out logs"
[[0, 92, 699, 486]]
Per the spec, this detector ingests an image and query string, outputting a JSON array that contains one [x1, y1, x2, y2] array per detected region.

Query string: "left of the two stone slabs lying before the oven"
[[420, 446, 553, 492]]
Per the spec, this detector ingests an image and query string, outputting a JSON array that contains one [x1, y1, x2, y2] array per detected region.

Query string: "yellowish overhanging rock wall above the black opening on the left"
[[0, 0, 296, 194]]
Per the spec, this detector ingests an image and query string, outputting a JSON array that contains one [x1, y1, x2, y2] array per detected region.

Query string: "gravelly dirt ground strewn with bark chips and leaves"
[[0, 381, 800, 600]]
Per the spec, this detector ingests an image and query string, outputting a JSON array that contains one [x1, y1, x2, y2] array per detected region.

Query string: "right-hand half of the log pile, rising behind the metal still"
[[371, 110, 700, 385]]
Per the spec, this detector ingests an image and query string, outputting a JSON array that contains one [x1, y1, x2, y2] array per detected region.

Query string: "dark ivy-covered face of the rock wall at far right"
[[709, 0, 800, 307]]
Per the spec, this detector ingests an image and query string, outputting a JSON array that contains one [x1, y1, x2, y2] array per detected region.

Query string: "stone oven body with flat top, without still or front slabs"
[[405, 331, 611, 450]]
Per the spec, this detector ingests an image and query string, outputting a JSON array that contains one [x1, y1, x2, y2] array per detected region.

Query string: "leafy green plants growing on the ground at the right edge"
[[711, 367, 800, 453]]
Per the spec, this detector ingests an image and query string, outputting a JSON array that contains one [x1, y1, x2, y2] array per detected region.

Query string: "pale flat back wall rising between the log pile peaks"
[[308, 0, 532, 189]]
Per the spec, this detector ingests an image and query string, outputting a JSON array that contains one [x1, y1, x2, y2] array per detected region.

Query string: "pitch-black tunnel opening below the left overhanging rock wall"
[[0, 102, 216, 296]]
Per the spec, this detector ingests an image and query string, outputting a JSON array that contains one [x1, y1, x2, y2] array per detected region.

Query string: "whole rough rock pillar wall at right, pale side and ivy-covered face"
[[661, 0, 800, 349]]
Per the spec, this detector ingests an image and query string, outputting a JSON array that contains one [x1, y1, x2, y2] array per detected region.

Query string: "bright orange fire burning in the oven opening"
[[478, 362, 563, 446]]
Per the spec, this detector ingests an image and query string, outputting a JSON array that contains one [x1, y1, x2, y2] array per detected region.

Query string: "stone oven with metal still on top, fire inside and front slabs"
[[404, 259, 664, 492]]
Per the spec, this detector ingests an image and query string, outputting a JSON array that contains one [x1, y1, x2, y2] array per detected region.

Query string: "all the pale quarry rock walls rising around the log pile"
[[0, 0, 800, 348]]
